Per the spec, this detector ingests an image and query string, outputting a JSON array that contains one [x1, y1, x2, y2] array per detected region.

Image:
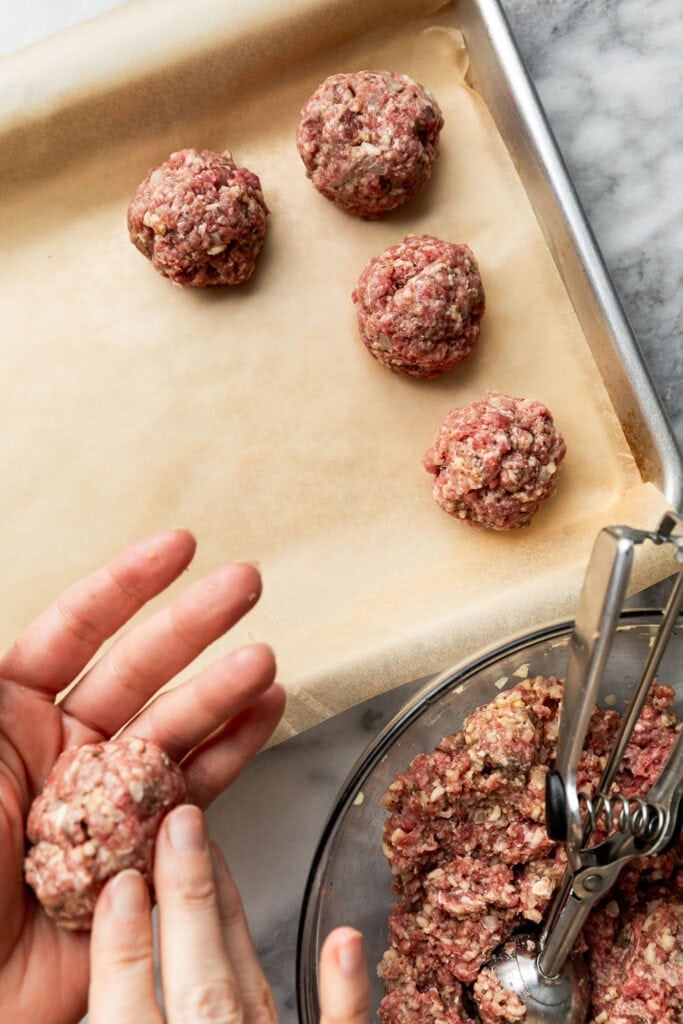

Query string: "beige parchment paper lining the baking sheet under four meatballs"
[[0, 0, 668, 736]]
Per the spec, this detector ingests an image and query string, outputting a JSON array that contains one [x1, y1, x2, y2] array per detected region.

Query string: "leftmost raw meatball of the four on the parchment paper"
[[128, 150, 268, 288]]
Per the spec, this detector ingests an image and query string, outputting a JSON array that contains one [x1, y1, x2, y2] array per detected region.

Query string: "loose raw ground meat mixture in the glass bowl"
[[379, 677, 683, 1024]]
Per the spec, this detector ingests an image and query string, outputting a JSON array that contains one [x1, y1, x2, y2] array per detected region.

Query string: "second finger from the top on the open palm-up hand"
[[62, 562, 261, 735]]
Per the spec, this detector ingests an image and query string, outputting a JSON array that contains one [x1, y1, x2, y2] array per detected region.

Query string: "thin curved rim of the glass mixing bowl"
[[295, 607, 671, 1024]]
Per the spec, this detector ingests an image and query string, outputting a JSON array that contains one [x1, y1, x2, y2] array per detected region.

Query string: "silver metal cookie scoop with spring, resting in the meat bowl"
[[487, 515, 683, 1024]]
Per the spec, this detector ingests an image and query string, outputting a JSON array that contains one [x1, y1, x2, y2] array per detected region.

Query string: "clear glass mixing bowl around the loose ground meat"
[[297, 611, 683, 1024]]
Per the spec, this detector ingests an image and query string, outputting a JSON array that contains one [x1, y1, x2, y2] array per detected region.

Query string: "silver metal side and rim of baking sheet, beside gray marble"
[[458, 0, 683, 508]]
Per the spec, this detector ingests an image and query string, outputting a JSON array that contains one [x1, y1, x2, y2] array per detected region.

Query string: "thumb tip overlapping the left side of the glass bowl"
[[319, 928, 370, 1024]]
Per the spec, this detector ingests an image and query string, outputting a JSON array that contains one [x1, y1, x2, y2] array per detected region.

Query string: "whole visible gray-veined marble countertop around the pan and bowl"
[[0, 0, 683, 1024]]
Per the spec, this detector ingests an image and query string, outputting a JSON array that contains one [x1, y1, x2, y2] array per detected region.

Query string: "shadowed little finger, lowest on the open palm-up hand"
[[181, 683, 286, 807]]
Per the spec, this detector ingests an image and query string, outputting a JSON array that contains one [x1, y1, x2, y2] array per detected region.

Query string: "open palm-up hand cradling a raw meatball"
[[0, 530, 285, 1024]]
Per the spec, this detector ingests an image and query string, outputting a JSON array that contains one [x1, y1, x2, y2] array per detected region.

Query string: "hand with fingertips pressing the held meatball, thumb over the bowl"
[[88, 806, 370, 1024]]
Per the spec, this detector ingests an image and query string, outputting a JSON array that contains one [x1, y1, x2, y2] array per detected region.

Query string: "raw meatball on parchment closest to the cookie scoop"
[[422, 391, 566, 529]]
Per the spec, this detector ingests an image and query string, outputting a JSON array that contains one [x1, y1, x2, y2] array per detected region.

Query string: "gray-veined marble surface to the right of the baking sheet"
[[504, 0, 683, 443]]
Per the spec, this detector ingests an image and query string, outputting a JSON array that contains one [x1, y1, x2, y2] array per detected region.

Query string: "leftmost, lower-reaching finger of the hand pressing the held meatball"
[[88, 868, 162, 1024]]
